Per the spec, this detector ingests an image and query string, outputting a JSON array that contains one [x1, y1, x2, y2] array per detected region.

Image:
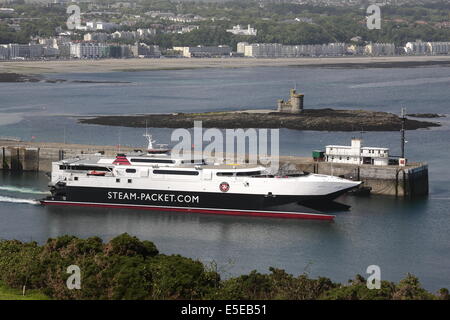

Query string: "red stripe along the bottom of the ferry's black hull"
[[41, 200, 335, 220]]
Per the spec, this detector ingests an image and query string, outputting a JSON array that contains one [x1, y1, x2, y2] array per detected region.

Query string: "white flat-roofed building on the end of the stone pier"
[[325, 138, 389, 166]]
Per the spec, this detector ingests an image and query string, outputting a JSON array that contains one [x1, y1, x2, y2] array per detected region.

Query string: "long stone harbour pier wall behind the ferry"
[[0, 140, 428, 199]]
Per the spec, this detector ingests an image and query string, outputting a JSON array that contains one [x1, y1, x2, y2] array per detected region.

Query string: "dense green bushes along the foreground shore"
[[0, 234, 449, 300]]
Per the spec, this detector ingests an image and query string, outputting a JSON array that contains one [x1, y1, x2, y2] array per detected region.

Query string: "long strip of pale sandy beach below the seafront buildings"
[[0, 56, 450, 74]]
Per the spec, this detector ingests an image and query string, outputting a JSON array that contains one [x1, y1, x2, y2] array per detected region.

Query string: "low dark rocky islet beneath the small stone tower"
[[79, 109, 440, 131]]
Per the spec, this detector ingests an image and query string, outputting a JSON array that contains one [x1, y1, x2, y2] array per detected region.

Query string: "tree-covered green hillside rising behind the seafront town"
[[0, 0, 450, 49]]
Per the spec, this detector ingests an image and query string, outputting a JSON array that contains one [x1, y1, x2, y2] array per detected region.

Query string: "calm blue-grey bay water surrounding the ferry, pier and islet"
[[0, 67, 450, 291]]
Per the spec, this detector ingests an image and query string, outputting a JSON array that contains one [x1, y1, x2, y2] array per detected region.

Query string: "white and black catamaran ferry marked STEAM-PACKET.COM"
[[41, 135, 361, 220]]
